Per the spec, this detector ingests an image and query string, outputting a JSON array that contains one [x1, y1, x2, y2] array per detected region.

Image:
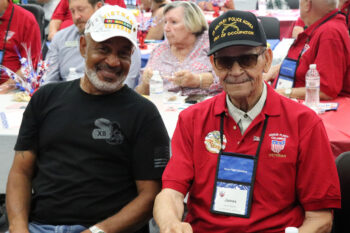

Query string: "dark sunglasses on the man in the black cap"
[[214, 49, 266, 70]]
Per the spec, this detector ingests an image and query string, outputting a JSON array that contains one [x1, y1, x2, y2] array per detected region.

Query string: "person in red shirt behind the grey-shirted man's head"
[[47, 0, 126, 41]]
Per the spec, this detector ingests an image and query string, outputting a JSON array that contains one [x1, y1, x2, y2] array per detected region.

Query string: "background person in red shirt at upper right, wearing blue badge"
[[265, 0, 350, 100]]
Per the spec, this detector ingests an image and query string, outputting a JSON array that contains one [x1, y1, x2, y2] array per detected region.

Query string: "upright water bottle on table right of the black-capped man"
[[305, 64, 320, 112]]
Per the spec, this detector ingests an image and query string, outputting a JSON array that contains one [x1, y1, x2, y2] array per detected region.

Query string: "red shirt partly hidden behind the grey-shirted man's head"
[[51, 0, 126, 30]]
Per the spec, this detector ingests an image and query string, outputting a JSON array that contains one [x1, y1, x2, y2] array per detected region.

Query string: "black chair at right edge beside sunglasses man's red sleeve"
[[332, 151, 350, 233]]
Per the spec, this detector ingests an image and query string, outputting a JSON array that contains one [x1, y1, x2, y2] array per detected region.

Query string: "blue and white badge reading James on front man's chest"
[[211, 153, 257, 218]]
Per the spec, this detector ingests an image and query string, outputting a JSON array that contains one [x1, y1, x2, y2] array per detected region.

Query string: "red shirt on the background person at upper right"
[[275, 10, 350, 98]]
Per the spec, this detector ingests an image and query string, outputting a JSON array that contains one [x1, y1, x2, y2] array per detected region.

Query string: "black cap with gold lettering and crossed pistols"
[[208, 10, 266, 56]]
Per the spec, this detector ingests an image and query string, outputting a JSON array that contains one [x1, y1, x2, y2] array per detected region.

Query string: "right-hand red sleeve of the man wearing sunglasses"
[[296, 120, 341, 211]]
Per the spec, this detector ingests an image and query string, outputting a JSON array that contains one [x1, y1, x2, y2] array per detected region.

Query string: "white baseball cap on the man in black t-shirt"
[[85, 5, 137, 47]]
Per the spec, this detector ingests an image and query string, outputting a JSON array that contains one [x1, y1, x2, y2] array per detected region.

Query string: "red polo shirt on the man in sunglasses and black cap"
[[162, 87, 341, 233]]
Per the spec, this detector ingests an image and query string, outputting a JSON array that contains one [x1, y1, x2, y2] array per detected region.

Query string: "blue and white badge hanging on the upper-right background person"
[[276, 58, 298, 89]]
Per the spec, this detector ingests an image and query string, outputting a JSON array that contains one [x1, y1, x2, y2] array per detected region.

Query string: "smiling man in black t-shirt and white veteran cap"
[[7, 6, 169, 233]]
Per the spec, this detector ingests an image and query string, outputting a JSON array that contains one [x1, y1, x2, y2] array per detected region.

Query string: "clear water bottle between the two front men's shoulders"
[[149, 70, 164, 109]]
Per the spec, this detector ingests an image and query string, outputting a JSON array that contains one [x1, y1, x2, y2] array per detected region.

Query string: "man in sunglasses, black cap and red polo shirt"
[[153, 11, 341, 233]]
